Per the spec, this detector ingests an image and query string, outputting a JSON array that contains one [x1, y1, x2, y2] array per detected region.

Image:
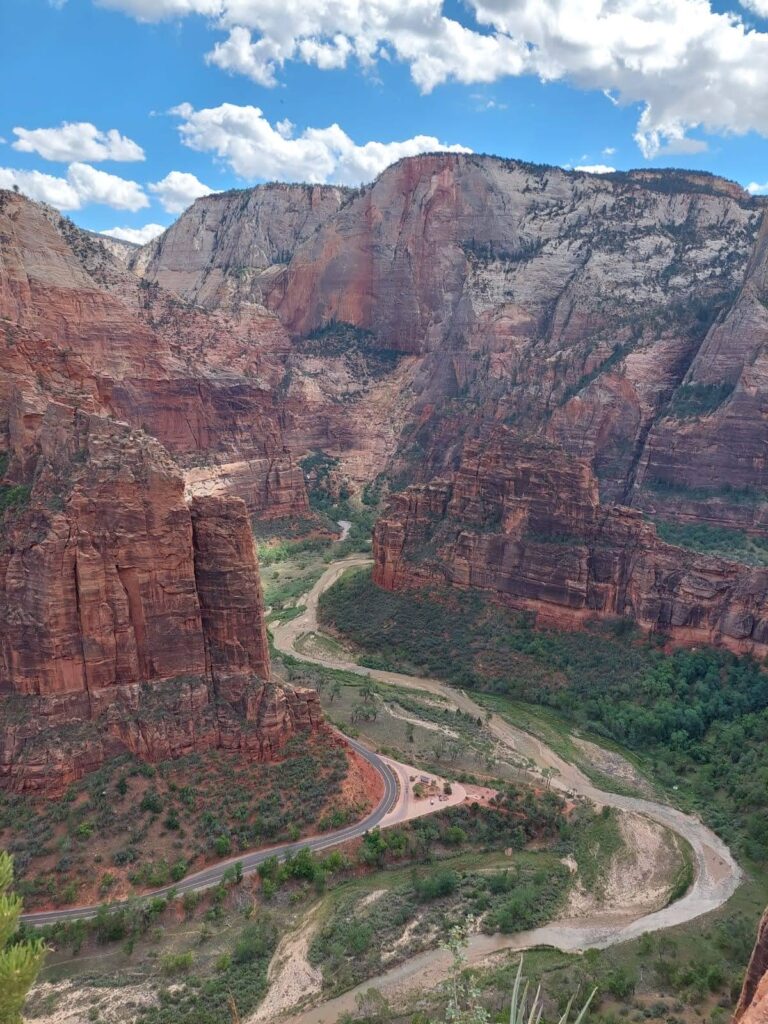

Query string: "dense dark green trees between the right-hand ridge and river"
[[321, 572, 768, 862]]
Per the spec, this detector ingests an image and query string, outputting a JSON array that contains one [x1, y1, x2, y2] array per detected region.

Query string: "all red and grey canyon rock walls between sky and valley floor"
[[0, 154, 768, 788]]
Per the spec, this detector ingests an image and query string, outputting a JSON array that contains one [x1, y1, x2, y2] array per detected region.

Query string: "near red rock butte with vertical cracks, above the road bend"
[[0, 402, 322, 793]]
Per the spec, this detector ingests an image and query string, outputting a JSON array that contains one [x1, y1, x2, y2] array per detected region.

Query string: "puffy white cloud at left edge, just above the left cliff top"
[[0, 163, 150, 211]]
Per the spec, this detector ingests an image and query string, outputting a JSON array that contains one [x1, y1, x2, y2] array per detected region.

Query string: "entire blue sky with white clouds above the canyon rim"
[[0, 0, 768, 237]]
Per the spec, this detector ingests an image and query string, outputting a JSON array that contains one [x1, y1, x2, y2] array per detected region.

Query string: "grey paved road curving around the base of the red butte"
[[22, 736, 398, 925]]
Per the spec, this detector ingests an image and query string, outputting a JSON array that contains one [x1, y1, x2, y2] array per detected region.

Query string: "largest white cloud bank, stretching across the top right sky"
[[98, 0, 768, 158]]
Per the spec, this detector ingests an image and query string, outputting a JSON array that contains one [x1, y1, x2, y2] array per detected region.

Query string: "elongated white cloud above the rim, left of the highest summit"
[[171, 103, 471, 185]]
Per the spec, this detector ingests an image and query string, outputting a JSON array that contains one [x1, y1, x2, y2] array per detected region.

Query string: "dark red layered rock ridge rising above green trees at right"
[[374, 428, 768, 655]]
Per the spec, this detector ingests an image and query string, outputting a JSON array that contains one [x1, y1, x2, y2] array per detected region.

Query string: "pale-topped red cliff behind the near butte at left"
[[0, 193, 307, 515]]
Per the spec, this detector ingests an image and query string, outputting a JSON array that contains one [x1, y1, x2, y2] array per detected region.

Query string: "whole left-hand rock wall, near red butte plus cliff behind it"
[[0, 193, 322, 793]]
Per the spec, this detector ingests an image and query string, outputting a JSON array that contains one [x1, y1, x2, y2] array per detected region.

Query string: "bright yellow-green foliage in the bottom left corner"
[[0, 850, 45, 1024]]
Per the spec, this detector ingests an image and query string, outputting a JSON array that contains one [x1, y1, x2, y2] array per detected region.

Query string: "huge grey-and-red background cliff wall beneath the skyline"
[[134, 154, 768, 532]]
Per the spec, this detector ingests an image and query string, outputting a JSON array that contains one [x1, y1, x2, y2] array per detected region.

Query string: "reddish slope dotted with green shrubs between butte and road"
[[0, 736, 354, 908]]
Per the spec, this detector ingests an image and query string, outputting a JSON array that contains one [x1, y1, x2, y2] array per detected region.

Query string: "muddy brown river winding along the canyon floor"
[[272, 557, 741, 1024]]
